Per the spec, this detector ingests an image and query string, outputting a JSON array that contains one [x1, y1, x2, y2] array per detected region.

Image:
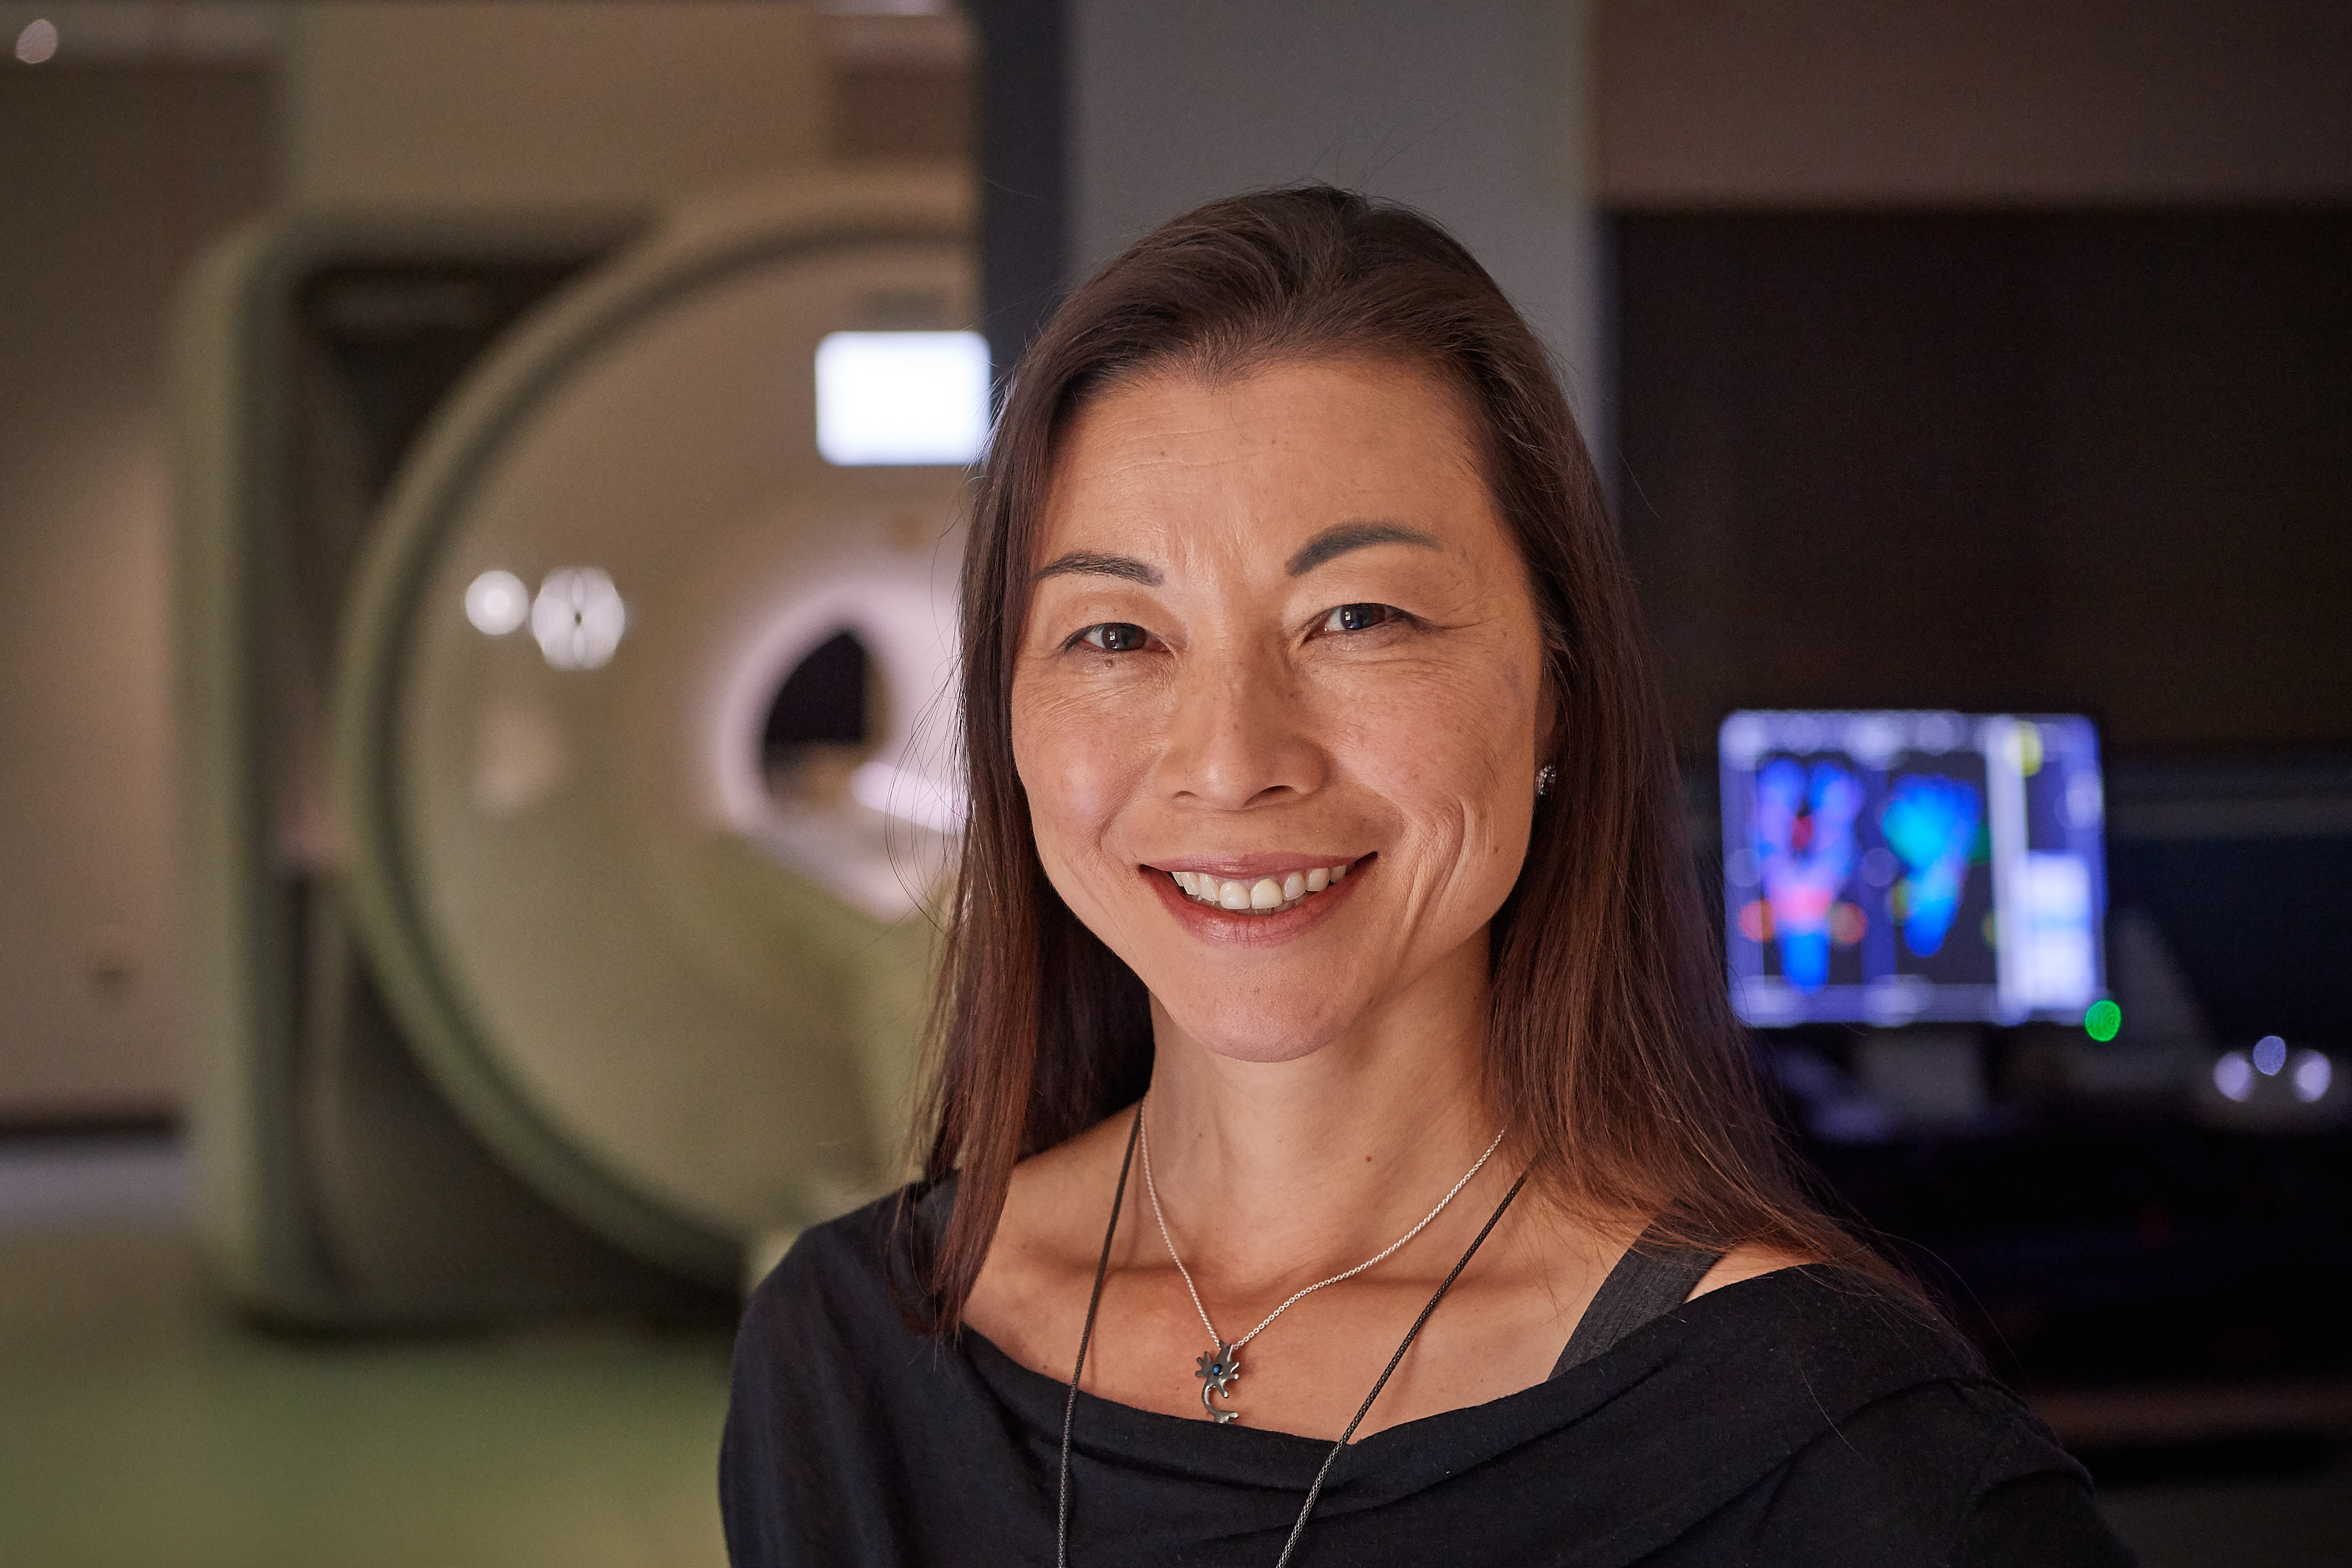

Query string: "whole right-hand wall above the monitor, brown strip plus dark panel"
[[1592, 0, 2352, 757]]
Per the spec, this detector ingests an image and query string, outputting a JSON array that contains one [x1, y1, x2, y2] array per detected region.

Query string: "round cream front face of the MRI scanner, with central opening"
[[190, 174, 988, 1317]]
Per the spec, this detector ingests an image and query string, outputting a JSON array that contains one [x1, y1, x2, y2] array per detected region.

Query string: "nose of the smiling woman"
[[1155, 646, 1329, 811]]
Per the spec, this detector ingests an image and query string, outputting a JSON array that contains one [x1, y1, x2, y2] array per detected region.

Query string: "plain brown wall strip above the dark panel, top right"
[[1592, 0, 2352, 207]]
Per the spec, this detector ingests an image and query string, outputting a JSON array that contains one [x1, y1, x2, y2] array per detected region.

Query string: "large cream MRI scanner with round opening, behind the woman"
[[176, 174, 988, 1326]]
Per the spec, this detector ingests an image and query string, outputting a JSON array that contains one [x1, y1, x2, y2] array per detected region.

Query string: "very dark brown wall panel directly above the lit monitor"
[[1618, 207, 2352, 757]]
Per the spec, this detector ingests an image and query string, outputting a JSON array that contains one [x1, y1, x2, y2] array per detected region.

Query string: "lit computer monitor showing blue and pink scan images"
[[1717, 710, 2107, 1032]]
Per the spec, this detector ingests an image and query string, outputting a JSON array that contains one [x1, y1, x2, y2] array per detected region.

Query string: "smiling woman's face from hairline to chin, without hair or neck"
[[1011, 360, 1543, 1060]]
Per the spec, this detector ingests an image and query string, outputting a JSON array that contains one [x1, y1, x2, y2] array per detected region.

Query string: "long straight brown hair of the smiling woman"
[[908, 186, 1884, 1330]]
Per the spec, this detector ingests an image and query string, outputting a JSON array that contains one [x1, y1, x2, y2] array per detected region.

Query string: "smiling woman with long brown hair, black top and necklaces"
[[722, 188, 2131, 1568]]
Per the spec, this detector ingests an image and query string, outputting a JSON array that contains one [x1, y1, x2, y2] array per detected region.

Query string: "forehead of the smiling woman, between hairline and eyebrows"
[[1035, 360, 1508, 564]]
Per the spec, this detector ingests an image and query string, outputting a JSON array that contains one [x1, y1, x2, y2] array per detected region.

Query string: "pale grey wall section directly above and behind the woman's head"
[[1068, 0, 1607, 444]]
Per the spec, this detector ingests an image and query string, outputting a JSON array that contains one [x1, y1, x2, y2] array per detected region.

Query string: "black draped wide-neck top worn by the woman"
[[720, 1199, 2133, 1568]]
